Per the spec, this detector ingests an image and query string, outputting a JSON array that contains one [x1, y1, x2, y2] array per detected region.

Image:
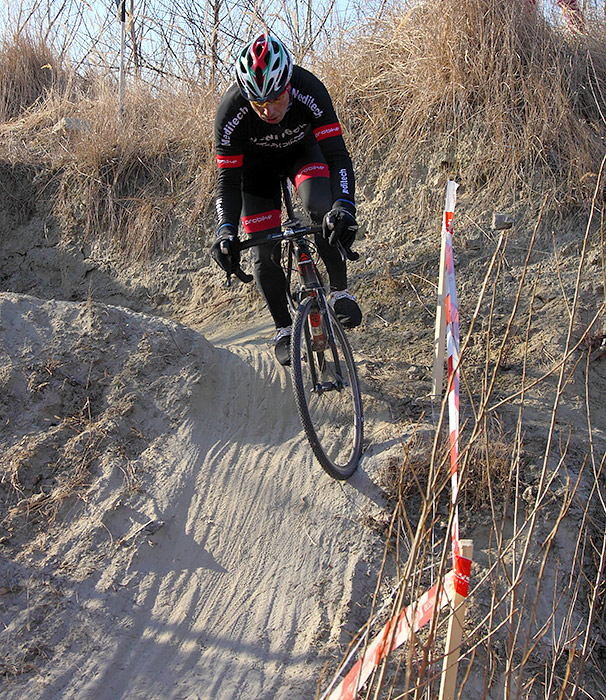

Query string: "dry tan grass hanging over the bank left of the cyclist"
[[0, 45, 216, 260]]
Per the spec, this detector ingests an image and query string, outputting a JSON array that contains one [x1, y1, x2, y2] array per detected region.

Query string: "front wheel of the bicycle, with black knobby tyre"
[[291, 297, 363, 479]]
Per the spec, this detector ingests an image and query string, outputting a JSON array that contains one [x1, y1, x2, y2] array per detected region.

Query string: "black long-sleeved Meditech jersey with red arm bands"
[[215, 66, 355, 228]]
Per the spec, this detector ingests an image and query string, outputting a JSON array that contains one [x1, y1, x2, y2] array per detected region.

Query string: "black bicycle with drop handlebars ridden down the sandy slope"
[[228, 178, 364, 480]]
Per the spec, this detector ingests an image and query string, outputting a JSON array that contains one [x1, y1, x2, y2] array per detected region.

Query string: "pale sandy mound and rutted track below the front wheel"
[[0, 293, 396, 700]]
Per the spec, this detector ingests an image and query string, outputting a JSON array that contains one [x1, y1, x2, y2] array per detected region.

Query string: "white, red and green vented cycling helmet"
[[236, 34, 292, 102]]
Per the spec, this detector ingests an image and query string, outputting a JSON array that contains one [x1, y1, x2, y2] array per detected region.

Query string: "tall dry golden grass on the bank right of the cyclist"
[[322, 0, 606, 221]]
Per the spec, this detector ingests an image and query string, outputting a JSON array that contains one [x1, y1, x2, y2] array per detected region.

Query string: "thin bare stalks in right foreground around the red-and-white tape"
[[318, 183, 606, 700]]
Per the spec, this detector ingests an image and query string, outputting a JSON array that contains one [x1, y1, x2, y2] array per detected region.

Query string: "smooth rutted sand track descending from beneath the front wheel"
[[2, 304, 388, 700]]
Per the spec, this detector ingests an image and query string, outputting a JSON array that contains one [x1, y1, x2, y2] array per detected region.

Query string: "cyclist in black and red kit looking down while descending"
[[211, 34, 362, 365]]
